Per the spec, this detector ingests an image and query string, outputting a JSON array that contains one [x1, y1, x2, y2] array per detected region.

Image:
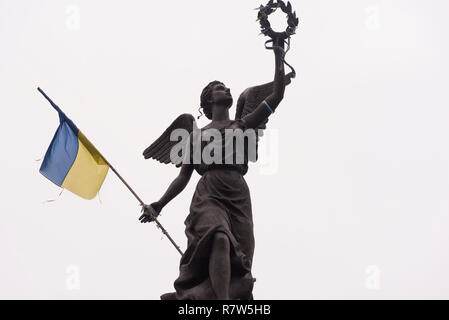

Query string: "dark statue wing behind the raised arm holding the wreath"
[[235, 72, 292, 160]]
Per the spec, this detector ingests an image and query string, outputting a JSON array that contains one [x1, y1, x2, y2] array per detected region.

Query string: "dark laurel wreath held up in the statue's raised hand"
[[256, 0, 299, 38]]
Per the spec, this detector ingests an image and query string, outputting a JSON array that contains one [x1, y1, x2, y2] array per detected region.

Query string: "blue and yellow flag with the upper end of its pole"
[[38, 88, 109, 200]]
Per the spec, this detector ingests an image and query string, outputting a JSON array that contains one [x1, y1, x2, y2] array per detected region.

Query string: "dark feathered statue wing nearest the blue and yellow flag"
[[143, 113, 198, 167]]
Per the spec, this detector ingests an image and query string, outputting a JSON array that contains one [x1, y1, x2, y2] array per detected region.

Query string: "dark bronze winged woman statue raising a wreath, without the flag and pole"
[[139, 0, 298, 300]]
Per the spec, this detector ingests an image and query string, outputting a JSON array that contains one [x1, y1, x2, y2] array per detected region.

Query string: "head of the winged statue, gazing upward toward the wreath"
[[201, 81, 232, 120]]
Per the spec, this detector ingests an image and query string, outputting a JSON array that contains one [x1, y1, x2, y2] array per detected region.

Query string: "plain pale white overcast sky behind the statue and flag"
[[0, 0, 449, 299]]
